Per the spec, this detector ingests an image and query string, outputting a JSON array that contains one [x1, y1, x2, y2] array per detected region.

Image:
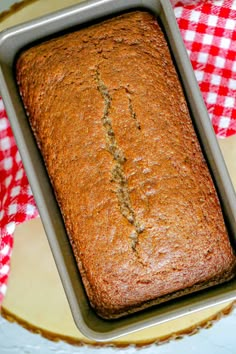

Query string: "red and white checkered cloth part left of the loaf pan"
[[0, 99, 38, 303]]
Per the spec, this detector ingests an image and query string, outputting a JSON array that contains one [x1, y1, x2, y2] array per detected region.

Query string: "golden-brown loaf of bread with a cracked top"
[[16, 11, 235, 318]]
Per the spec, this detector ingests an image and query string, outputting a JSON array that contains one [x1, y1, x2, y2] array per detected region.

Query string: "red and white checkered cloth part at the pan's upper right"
[[175, 0, 236, 137]]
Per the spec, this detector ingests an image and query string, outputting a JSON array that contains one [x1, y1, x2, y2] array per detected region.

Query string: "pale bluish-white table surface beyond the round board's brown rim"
[[0, 0, 236, 354]]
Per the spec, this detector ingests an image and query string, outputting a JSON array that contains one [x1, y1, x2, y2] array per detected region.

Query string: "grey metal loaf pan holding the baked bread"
[[0, 0, 236, 341]]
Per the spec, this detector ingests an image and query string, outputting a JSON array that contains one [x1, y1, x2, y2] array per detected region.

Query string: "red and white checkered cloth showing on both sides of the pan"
[[0, 0, 236, 304]]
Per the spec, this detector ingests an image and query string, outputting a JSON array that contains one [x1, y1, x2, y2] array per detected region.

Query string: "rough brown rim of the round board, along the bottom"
[[0, 301, 236, 348]]
